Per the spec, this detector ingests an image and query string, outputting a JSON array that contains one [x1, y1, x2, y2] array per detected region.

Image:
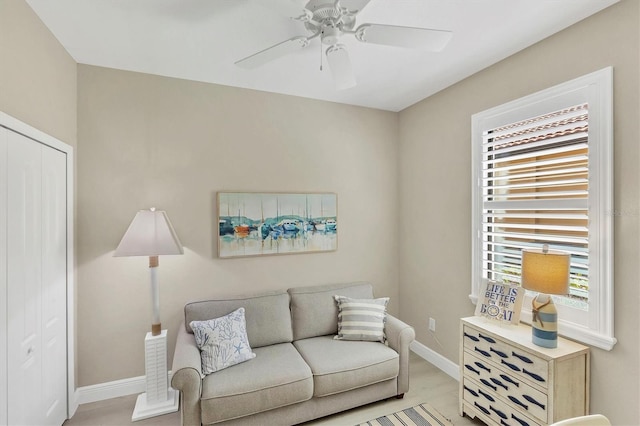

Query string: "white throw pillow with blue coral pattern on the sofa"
[[189, 308, 256, 375]]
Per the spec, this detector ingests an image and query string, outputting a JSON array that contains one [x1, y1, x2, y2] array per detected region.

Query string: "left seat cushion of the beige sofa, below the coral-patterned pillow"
[[201, 343, 313, 424]]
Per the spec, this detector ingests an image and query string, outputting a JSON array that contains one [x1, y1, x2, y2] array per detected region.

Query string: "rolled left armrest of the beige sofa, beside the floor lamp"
[[171, 324, 203, 425]]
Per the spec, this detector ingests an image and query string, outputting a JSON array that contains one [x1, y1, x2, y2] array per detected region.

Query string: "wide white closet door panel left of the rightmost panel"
[[7, 132, 43, 425]]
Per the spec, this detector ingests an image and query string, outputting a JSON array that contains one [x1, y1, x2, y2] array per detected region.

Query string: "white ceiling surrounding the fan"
[[27, 0, 618, 111]]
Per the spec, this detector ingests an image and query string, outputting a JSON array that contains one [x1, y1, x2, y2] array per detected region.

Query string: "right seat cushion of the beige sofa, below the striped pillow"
[[293, 336, 400, 397]]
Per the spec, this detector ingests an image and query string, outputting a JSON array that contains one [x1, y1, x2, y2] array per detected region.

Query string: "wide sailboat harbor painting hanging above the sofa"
[[217, 192, 338, 258]]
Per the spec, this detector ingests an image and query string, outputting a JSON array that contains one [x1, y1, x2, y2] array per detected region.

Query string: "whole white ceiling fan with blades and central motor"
[[235, 0, 452, 90]]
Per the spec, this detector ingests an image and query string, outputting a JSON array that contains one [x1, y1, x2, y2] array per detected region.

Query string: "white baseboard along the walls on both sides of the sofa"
[[73, 341, 460, 411]]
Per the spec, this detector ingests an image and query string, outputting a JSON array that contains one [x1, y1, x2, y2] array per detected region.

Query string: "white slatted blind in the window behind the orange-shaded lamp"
[[481, 103, 589, 300]]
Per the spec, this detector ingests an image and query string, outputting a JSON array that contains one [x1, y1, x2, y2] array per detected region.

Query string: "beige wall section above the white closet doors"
[[0, 0, 77, 147]]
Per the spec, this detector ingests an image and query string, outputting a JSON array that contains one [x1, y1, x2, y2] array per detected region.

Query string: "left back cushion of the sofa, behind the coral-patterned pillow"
[[184, 290, 293, 348]]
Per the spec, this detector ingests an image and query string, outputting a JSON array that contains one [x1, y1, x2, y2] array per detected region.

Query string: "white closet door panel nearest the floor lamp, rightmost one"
[[42, 146, 67, 425]]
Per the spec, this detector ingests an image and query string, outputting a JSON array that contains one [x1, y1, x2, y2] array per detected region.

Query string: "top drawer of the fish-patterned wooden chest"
[[463, 326, 549, 387]]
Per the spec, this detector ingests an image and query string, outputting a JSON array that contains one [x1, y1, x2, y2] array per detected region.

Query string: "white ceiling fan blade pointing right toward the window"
[[355, 24, 453, 52]]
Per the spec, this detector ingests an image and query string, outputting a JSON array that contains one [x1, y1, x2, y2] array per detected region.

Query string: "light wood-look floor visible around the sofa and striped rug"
[[64, 354, 482, 426]]
